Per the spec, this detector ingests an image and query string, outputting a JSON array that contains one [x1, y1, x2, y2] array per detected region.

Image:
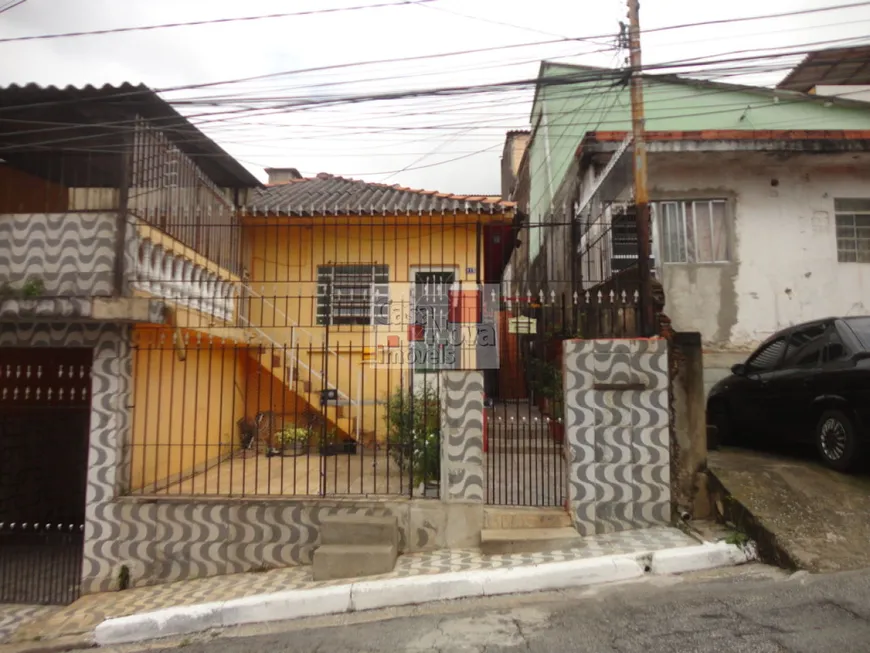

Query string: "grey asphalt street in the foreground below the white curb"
[[117, 565, 870, 653]]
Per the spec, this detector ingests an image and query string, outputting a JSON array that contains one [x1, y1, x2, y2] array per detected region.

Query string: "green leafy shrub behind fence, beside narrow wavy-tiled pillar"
[[384, 388, 441, 483]]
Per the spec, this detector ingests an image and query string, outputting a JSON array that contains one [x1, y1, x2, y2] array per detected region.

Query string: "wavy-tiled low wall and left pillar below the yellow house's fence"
[[0, 323, 446, 593]]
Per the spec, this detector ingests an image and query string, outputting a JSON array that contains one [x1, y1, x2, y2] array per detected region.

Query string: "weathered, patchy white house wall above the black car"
[[650, 152, 870, 348]]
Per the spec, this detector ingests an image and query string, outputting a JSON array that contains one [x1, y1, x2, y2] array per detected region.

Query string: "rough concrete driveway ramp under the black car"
[[708, 449, 870, 572]]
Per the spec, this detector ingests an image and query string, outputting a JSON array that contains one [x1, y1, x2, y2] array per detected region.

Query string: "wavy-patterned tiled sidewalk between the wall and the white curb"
[[1, 527, 698, 642]]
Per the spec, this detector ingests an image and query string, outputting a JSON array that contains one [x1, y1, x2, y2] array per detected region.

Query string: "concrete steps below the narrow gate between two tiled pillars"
[[480, 506, 582, 555]]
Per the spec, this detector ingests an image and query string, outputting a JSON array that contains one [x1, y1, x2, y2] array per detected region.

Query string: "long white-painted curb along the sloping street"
[[94, 543, 752, 646]]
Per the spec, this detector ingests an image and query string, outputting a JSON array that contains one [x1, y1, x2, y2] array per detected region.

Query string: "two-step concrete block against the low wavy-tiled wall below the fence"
[[313, 515, 399, 580]]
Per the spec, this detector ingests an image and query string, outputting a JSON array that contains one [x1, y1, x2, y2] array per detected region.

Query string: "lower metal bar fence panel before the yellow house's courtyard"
[[130, 330, 441, 497]]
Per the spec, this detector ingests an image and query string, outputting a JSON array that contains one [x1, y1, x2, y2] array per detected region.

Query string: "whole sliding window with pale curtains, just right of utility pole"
[[655, 199, 730, 263]]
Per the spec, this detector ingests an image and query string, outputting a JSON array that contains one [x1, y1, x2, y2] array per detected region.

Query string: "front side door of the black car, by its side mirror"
[[730, 335, 788, 435]]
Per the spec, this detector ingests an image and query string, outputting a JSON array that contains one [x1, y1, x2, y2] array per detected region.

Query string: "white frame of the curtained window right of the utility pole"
[[652, 197, 734, 265]]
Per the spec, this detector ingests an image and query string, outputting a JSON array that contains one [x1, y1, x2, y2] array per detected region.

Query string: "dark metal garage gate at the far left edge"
[[0, 348, 93, 604]]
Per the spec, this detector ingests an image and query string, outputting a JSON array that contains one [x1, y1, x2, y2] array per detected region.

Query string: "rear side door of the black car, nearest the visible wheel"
[[767, 322, 831, 441]]
